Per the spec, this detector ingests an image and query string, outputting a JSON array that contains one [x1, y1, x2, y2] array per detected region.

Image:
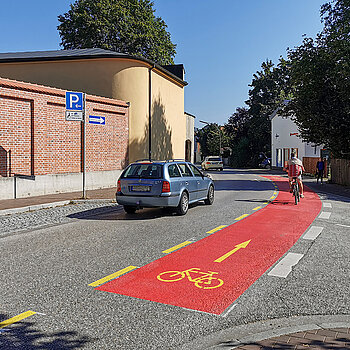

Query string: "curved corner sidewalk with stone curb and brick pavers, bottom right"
[[182, 315, 350, 350]]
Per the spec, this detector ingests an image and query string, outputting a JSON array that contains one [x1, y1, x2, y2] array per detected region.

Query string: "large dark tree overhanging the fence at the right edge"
[[286, 0, 350, 158]]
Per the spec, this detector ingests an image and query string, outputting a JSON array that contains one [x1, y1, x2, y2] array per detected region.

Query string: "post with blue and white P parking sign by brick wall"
[[65, 91, 86, 199]]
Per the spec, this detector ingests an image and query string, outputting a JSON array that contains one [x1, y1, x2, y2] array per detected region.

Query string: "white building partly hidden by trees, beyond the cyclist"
[[270, 108, 323, 168]]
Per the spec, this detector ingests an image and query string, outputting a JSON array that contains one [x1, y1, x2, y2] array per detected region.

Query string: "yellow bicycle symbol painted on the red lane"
[[157, 267, 224, 289]]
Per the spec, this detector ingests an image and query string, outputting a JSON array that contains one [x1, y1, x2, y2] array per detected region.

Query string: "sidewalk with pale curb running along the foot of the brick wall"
[[0, 187, 116, 216]]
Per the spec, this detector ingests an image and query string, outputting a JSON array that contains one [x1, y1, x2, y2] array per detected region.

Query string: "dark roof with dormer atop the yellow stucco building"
[[0, 48, 187, 85]]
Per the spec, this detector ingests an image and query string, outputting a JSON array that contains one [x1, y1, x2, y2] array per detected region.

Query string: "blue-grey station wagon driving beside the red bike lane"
[[116, 160, 214, 215]]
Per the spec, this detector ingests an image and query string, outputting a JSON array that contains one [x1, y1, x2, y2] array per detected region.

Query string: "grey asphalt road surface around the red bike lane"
[[0, 169, 350, 350]]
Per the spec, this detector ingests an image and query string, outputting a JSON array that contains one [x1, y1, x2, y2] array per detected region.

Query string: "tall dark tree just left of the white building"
[[225, 58, 290, 167]]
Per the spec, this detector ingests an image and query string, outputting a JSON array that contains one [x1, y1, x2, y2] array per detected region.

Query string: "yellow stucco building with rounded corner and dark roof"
[[0, 49, 189, 161]]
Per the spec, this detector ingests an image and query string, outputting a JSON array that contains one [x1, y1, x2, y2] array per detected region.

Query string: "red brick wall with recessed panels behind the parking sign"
[[0, 78, 128, 177]]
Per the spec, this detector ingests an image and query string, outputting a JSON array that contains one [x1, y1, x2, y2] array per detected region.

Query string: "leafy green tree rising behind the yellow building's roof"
[[57, 0, 176, 65]]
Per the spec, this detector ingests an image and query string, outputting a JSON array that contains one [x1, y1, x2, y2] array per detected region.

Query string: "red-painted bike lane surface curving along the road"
[[96, 176, 322, 315]]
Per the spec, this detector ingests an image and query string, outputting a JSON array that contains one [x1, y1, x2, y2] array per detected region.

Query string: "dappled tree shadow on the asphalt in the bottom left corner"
[[0, 314, 97, 350]]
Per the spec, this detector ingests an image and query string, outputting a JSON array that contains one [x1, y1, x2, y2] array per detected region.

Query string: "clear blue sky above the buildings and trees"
[[0, 0, 326, 127]]
